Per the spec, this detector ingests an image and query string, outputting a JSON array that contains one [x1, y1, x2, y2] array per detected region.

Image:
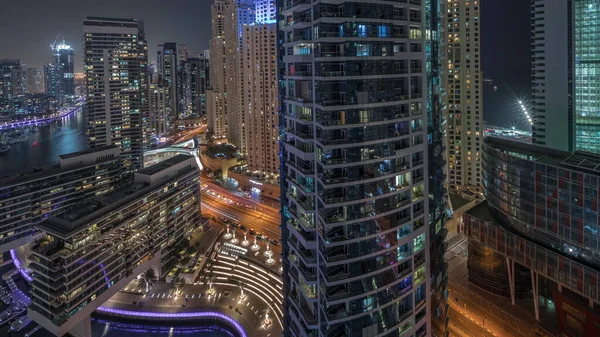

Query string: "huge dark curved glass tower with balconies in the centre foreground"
[[278, 0, 431, 337]]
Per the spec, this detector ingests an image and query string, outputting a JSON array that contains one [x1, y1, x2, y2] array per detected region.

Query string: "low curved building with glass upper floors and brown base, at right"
[[464, 137, 600, 336]]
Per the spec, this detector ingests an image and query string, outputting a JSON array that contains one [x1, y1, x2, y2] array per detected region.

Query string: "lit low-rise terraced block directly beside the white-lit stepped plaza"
[[28, 155, 200, 336]]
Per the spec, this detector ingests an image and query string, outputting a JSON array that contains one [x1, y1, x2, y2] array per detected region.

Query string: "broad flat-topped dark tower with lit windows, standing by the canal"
[[83, 17, 148, 171]]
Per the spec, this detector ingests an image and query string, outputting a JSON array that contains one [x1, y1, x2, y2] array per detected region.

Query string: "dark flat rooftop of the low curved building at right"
[[483, 136, 600, 175]]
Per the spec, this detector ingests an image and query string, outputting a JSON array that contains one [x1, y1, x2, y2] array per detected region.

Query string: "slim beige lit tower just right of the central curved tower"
[[443, 0, 483, 191]]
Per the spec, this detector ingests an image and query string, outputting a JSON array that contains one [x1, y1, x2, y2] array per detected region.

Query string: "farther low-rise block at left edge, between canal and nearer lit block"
[[0, 146, 122, 252]]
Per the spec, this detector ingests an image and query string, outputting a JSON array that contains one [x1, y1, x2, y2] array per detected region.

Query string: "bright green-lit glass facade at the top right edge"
[[573, 0, 600, 153]]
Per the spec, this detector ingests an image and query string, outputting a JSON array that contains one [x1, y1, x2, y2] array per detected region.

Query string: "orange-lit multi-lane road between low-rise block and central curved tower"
[[202, 191, 281, 241]]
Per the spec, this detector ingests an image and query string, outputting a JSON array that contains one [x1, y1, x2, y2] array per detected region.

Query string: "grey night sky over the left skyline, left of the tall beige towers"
[[0, 0, 212, 71]]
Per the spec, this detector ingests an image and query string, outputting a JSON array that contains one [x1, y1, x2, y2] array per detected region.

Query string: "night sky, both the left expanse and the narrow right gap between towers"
[[0, 0, 530, 125]]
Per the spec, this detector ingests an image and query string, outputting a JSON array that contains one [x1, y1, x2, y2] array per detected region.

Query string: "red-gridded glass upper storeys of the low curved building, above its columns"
[[465, 137, 600, 303]]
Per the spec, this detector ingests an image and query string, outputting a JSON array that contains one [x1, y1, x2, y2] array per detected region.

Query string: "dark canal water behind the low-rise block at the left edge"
[[0, 109, 88, 177]]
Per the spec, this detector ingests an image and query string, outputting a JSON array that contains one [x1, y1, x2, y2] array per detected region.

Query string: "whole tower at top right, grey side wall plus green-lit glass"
[[531, 0, 600, 153]]
